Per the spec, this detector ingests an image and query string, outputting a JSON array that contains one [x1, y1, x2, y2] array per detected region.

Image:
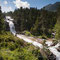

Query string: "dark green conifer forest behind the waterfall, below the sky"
[[6, 8, 57, 35]]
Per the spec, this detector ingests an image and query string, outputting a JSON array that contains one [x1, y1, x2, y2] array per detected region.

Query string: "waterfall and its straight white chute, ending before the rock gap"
[[5, 16, 43, 48]]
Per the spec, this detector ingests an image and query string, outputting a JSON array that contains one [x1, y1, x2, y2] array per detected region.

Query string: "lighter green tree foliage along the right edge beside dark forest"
[[55, 7, 60, 40]]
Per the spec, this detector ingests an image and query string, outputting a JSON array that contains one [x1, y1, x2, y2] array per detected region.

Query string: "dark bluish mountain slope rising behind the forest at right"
[[43, 2, 60, 12]]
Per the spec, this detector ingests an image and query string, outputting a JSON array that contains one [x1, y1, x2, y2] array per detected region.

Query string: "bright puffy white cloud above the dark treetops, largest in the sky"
[[13, 0, 30, 8]]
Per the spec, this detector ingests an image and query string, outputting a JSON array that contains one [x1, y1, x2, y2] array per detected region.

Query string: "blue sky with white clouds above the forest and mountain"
[[0, 0, 60, 12]]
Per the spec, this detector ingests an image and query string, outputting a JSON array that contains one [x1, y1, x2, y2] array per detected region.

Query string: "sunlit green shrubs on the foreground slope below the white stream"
[[0, 32, 47, 60]]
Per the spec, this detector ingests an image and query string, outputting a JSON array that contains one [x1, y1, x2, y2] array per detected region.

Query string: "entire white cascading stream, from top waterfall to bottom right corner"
[[5, 16, 60, 60]]
